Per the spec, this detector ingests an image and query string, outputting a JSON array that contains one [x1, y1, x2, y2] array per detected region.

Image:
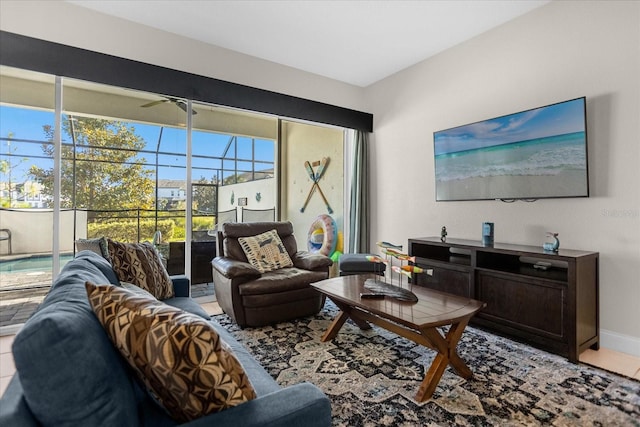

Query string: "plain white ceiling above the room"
[[69, 0, 551, 87]]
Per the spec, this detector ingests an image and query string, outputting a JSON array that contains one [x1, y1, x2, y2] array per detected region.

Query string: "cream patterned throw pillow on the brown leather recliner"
[[238, 230, 293, 273]]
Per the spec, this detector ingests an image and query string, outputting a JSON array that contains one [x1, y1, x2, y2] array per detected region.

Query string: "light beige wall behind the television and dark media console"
[[366, 1, 640, 356]]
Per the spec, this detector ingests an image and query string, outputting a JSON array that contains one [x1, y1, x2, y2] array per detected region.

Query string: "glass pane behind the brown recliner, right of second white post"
[[191, 104, 277, 283]]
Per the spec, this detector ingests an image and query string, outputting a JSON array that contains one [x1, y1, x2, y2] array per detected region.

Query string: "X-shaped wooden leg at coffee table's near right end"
[[416, 319, 473, 402]]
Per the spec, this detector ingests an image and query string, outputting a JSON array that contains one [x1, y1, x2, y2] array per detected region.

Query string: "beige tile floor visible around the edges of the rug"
[[0, 306, 640, 395]]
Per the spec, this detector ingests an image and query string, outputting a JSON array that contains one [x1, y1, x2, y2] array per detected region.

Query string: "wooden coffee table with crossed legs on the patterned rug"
[[311, 275, 486, 402]]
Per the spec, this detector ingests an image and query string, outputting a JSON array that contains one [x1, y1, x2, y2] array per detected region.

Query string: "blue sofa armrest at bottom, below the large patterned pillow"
[[184, 383, 331, 427]]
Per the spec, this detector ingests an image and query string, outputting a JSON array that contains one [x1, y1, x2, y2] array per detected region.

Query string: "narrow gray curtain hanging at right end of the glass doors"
[[349, 130, 369, 253]]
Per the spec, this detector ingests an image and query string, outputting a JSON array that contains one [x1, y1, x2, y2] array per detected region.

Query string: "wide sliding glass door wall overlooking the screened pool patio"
[[0, 66, 344, 326]]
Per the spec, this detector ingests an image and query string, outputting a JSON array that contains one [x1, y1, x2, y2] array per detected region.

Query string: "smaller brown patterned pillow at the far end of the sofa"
[[108, 239, 174, 300]]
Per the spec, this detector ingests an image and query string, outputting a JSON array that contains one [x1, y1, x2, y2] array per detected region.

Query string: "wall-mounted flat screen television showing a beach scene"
[[433, 97, 589, 201]]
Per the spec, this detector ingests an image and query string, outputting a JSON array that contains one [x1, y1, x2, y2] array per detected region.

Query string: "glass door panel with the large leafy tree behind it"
[[62, 80, 186, 260]]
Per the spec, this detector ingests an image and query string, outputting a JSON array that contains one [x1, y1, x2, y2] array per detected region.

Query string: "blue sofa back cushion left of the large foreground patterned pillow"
[[13, 251, 138, 426]]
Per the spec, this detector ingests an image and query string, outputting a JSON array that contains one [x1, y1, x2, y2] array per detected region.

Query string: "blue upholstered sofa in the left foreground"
[[0, 251, 331, 427]]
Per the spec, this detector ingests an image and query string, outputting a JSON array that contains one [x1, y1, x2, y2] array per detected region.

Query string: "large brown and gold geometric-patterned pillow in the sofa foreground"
[[85, 282, 256, 422]]
